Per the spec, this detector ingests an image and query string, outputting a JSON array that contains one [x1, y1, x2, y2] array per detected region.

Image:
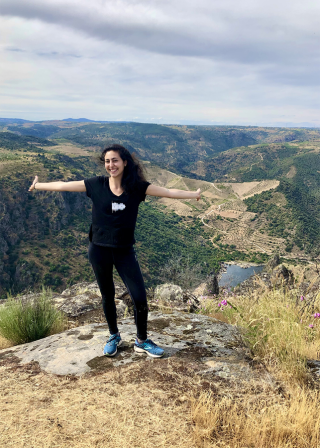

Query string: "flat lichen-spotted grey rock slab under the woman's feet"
[[0, 312, 261, 380]]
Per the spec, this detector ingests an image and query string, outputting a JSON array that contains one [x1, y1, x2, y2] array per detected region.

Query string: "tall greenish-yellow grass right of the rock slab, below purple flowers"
[[201, 276, 320, 385]]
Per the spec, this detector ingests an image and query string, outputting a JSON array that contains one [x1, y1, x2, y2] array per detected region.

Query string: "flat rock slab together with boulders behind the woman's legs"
[[0, 276, 272, 384]]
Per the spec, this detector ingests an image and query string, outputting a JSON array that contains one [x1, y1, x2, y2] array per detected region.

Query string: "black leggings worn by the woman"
[[89, 243, 148, 340]]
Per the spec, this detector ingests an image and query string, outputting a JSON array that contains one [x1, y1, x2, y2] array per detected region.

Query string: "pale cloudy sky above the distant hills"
[[0, 0, 320, 126]]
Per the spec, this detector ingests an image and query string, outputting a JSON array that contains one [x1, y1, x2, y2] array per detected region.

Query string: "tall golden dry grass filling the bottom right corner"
[[192, 389, 320, 448]]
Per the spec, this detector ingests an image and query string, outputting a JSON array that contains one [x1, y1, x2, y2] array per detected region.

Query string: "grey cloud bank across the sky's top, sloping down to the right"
[[0, 0, 320, 64]]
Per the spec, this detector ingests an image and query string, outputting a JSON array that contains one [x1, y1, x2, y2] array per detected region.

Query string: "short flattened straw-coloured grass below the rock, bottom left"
[[0, 364, 195, 448]]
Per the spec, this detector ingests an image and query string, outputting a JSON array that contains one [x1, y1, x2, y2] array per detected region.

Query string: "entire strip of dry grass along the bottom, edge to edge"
[[0, 360, 320, 448]]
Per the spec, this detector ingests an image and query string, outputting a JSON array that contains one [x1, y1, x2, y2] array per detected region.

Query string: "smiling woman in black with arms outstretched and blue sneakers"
[[29, 145, 200, 358]]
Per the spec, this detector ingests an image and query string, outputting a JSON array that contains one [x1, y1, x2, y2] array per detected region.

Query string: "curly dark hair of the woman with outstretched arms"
[[100, 144, 146, 193]]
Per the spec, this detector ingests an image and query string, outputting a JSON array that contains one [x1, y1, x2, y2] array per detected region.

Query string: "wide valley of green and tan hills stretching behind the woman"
[[0, 117, 320, 296]]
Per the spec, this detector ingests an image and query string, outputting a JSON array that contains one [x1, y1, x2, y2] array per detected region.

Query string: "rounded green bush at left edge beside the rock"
[[0, 288, 64, 345]]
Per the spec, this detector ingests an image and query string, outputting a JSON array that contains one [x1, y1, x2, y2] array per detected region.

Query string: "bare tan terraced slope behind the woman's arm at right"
[[147, 165, 287, 255]]
